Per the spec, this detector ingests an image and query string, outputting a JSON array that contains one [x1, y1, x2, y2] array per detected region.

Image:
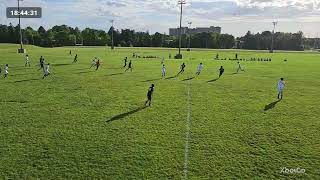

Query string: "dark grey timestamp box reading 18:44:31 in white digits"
[[6, 7, 42, 18]]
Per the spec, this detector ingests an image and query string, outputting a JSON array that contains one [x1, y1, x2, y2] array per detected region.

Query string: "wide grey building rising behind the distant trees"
[[169, 26, 221, 36]]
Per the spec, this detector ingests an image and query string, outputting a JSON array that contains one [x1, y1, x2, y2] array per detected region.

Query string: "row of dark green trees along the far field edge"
[[0, 23, 320, 51]]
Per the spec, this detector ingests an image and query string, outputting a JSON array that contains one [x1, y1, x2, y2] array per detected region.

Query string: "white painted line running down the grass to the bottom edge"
[[183, 85, 191, 179]]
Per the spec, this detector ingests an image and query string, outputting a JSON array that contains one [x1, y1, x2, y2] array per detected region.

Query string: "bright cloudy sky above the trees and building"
[[0, 0, 320, 37]]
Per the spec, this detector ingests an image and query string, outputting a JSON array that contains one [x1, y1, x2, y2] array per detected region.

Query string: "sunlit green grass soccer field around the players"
[[0, 44, 320, 179]]
